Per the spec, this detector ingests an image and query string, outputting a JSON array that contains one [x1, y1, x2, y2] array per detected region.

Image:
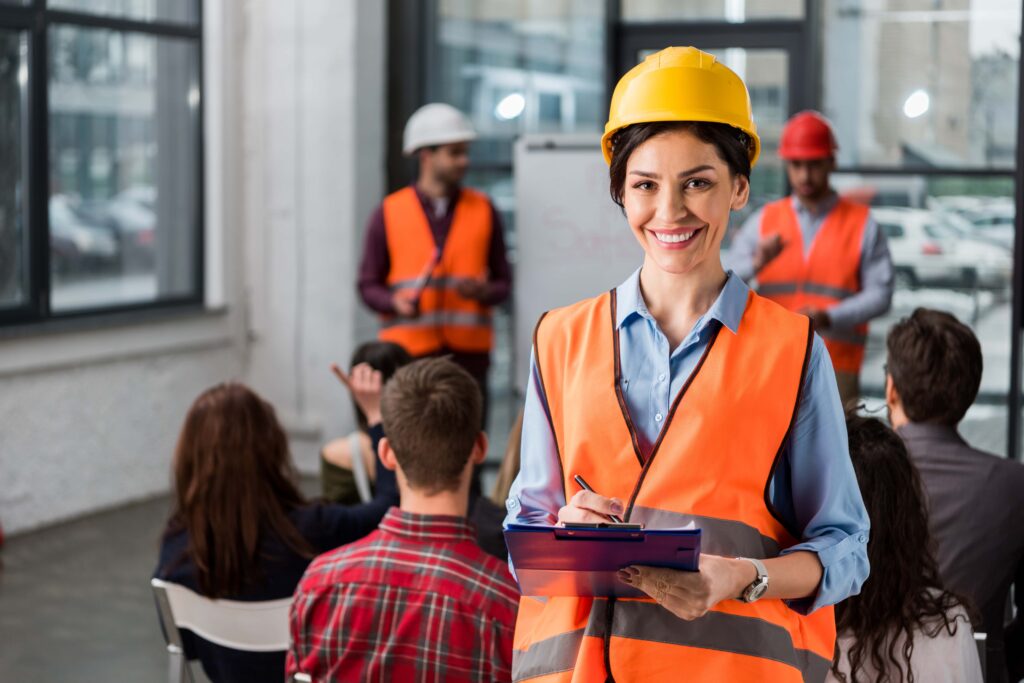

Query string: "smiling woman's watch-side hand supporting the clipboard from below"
[[610, 557, 758, 622]]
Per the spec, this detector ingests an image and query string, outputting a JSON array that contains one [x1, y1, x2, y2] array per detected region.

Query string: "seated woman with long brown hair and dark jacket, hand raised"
[[156, 366, 398, 683]]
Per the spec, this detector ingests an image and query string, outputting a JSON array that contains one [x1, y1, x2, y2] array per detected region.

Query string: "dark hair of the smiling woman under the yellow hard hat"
[[608, 121, 754, 206]]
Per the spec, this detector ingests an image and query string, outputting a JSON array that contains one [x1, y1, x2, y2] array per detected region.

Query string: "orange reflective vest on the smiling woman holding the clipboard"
[[512, 291, 836, 683]]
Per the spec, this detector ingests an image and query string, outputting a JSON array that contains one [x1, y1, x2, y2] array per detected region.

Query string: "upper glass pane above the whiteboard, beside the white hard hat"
[[429, 0, 607, 170]]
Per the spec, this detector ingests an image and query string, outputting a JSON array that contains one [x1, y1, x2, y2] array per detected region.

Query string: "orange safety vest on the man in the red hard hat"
[[758, 198, 868, 373]]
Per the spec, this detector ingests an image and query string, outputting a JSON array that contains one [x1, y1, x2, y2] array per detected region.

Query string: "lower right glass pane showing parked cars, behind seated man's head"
[[834, 174, 1015, 454]]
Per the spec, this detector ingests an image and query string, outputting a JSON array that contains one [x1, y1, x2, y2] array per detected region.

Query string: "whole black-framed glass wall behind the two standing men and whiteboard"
[[411, 0, 1024, 453]]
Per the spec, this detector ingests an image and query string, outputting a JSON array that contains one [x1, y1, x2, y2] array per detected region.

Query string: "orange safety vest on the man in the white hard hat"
[[379, 187, 494, 356]]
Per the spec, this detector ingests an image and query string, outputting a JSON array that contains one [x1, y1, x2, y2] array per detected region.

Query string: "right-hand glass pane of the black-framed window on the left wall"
[[49, 26, 199, 311]]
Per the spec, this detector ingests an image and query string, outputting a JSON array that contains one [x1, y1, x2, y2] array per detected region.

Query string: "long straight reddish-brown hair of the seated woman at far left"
[[167, 383, 313, 598]]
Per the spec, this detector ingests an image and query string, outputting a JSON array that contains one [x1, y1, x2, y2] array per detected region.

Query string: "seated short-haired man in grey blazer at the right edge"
[[886, 308, 1024, 683]]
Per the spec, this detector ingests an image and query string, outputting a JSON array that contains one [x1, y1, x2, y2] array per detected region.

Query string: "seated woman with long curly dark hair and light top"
[[828, 415, 982, 683]]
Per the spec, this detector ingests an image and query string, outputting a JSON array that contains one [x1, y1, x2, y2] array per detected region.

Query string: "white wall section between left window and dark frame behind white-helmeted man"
[[243, 0, 386, 470]]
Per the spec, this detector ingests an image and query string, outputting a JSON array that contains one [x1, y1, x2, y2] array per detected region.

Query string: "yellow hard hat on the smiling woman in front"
[[601, 47, 761, 167]]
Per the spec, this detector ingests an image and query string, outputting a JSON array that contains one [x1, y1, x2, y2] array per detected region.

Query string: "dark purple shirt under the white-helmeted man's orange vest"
[[357, 184, 512, 378]]
